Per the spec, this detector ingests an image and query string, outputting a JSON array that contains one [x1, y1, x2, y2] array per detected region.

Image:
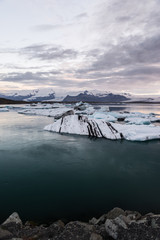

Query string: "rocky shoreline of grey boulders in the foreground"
[[0, 208, 160, 240]]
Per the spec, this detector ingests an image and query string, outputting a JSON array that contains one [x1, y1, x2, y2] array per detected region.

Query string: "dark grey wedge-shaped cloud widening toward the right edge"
[[84, 35, 160, 72]]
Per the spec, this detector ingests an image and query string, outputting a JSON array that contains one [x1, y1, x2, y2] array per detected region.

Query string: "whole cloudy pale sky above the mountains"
[[0, 0, 160, 95]]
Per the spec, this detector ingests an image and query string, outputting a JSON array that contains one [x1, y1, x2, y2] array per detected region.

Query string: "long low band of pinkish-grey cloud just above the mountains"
[[1, 68, 159, 93]]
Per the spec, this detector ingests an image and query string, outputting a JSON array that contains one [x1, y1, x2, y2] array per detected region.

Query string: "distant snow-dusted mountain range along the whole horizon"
[[0, 89, 160, 103]]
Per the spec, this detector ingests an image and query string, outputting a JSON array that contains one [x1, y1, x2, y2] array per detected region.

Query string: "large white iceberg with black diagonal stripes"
[[44, 115, 160, 141]]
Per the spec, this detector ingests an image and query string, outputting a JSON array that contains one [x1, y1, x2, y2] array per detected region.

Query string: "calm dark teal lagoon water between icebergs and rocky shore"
[[0, 105, 160, 222]]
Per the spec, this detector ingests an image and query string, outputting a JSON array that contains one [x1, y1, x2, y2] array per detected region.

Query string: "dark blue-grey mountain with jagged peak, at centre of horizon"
[[63, 91, 129, 103]]
